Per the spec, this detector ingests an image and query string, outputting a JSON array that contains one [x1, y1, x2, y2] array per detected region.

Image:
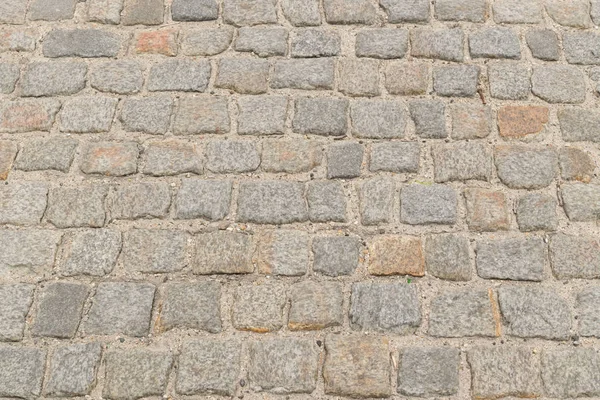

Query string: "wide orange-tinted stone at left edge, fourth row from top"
[[0, 99, 60, 133]]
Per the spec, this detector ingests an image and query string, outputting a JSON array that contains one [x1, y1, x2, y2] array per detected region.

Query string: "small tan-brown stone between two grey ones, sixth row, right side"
[[465, 188, 510, 232]]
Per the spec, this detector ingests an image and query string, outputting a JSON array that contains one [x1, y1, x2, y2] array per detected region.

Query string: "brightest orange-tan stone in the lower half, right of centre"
[[368, 235, 425, 276]]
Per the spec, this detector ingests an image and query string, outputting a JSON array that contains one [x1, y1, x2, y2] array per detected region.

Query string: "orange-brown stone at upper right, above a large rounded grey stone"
[[498, 106, 548, 138]]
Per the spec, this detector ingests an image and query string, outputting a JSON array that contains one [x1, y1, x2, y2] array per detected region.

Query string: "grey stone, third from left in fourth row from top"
[[119, 96, 173, 134]]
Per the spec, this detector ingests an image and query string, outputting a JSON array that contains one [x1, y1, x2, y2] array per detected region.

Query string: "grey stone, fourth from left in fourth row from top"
[[173, 96, 230, 135]]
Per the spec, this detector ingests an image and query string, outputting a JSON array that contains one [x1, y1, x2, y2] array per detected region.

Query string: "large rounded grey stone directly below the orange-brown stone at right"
[[494, 145, 558, 189]]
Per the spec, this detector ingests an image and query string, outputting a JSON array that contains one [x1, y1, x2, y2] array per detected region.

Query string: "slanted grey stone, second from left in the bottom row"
[[44, 343, 102, 397]]
